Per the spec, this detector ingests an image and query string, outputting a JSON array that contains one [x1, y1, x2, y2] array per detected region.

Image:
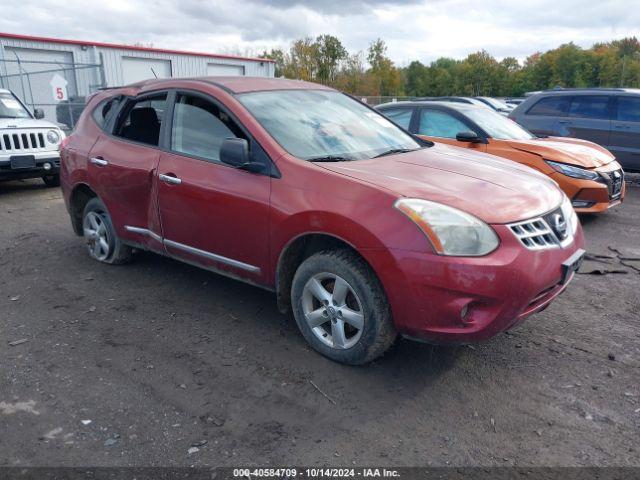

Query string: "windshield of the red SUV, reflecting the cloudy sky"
[[238, 90, 422, 161]]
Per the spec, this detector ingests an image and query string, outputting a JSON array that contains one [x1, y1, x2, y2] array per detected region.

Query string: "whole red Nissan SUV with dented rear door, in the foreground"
[[61, 77, 584, 364]]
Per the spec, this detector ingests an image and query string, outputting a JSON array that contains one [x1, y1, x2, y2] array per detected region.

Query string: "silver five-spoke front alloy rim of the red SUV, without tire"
[[302, 272, 364, 349]]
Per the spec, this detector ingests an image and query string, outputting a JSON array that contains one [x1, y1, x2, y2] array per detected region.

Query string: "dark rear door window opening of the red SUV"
[[115, 93, 167, 146]]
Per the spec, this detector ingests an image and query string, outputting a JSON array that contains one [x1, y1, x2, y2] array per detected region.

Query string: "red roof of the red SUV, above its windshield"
[[110, 76, 333, 94]]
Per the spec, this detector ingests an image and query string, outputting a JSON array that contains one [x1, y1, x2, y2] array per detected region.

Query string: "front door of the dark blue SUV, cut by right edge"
[[607, 95, 640, 171]]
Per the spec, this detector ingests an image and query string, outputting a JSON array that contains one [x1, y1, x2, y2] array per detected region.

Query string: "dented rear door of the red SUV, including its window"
[[88, 92, 167, 250]]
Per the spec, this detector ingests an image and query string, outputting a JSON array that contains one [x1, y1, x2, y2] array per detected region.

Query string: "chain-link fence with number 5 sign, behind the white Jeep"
[[0, 48, 105, 131]]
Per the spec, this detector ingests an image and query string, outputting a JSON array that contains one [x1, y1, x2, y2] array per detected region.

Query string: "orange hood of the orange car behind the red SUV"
[[507, 137, 615, 168]]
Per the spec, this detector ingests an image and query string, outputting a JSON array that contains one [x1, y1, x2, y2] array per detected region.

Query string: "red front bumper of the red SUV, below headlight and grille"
[[370, 225, 584, 343]]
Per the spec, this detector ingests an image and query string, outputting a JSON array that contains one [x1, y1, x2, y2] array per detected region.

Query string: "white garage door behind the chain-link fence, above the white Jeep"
[[2, 47, 77, 121]]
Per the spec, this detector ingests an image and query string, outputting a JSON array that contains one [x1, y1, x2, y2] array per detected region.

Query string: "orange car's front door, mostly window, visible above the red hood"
[[415, 107, 487, 151]]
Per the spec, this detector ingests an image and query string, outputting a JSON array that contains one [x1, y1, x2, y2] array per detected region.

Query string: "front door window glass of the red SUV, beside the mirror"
[[171, 95, 246, 162]]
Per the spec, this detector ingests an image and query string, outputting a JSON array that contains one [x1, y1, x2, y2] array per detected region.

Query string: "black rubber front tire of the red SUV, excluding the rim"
[[291, 250, 397, 365]]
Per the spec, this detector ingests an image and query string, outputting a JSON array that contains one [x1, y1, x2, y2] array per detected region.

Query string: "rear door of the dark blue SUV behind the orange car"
[[558, 95, 612, 147]]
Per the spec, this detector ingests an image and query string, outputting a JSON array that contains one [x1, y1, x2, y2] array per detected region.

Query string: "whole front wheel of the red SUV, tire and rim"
[[291, 250, 397, 365]]
